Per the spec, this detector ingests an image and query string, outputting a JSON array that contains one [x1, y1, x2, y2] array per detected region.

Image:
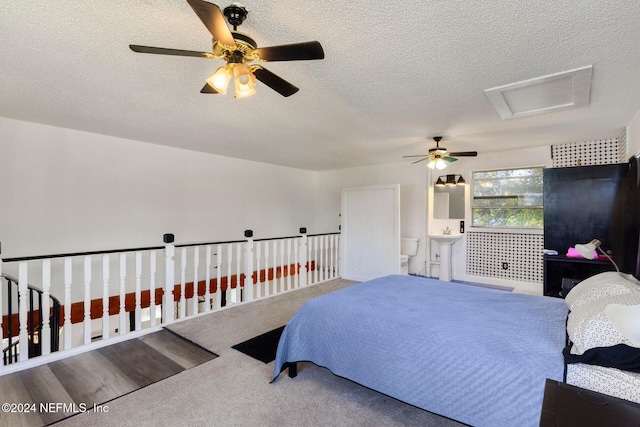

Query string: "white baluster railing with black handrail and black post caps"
[[0, 229, 339, 375]]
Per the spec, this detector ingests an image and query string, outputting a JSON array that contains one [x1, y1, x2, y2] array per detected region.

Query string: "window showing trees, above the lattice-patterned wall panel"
[[471, 167, 543, 228]]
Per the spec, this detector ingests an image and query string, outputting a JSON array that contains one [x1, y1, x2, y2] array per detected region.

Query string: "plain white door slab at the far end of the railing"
[[340, 184, 400, 281]]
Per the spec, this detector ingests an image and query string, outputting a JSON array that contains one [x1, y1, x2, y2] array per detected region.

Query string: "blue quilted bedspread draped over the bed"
[[273, 276, 568, 427]]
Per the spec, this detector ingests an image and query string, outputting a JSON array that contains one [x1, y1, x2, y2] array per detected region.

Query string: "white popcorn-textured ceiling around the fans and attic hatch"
[[0, 0, 640, 170]]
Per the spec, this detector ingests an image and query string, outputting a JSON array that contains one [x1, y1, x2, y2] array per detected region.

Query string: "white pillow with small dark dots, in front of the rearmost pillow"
[[567, 292, 640, 354]]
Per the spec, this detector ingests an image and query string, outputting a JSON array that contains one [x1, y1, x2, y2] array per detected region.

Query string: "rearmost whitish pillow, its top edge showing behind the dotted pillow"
[[565, 271, 640, 310]]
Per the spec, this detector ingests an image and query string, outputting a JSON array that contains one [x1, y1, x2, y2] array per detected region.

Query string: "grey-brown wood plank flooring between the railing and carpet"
[[0, 329, 217, 427]]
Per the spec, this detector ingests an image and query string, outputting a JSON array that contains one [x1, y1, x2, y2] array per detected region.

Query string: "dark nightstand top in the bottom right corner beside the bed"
[[540, 379, 640, 427]]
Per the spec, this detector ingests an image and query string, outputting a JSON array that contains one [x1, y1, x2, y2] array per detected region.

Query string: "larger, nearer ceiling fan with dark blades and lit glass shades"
[[129, 0, 324, 98]]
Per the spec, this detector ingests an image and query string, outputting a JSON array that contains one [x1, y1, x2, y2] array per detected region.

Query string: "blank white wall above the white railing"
[[0, 118, 318, 258]]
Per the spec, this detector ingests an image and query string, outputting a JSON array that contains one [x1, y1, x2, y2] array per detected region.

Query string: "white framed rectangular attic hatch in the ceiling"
[[484, 65, 593, 119]]
